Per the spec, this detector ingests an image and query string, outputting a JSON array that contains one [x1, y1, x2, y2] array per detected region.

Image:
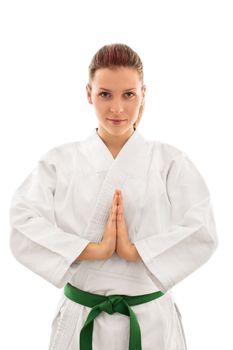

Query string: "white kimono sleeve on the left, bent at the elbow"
[[10, 152, 89, 288]]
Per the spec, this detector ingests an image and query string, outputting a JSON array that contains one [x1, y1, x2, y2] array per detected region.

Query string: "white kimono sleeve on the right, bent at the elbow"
[[134, 152, 218, 292]]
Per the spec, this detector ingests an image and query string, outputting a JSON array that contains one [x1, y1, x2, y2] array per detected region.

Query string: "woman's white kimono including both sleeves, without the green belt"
[[10, 128, 218, 350]]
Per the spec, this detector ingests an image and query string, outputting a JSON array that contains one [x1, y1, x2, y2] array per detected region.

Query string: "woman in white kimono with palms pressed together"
[[10, 44, 218, 350]]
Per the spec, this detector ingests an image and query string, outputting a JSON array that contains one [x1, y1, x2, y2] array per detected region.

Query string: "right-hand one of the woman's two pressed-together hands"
[[116, 190, 141, 261]]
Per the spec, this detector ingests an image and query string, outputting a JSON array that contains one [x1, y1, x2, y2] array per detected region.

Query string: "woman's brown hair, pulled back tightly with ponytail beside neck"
[[88, 43, 145, 130]]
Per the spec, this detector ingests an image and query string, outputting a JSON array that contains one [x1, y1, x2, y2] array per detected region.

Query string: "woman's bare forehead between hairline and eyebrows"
[[93, 67, 140, 90]]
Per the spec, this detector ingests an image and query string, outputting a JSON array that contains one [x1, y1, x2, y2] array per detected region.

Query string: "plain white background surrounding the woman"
[[0, 0, 233, 350]]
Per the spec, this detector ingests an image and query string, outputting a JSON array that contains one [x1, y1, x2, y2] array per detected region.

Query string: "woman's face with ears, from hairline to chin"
[[86, 67, 146, 135]]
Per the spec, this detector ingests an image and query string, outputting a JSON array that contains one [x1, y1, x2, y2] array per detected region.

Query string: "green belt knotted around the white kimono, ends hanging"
[[64, 283, 165, 350]]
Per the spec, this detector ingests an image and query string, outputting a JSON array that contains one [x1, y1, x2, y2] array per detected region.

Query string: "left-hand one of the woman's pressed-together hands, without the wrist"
[[99, 191, 117, 258]]
